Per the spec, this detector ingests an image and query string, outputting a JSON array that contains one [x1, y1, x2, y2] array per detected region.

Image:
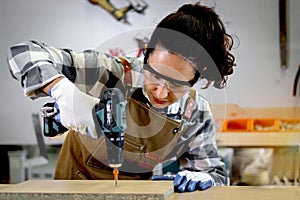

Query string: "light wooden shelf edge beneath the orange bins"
[[217, 132, 300, 147]]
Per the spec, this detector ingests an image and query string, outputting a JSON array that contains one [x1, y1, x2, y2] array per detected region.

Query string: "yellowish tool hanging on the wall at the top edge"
[[89, 0, 148, 24]]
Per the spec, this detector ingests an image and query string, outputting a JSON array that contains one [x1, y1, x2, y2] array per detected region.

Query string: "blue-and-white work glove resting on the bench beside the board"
[[174, 170, 215, 192]]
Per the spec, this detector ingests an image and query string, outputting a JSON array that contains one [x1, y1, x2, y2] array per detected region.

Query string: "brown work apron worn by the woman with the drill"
[[54, 89, 195, 179]]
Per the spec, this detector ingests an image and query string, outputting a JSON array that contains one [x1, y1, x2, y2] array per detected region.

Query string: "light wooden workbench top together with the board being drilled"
[[0, 180, 300, 200]]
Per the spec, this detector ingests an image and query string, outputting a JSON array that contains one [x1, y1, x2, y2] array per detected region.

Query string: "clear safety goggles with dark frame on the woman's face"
[[143, 64, 200, 93]]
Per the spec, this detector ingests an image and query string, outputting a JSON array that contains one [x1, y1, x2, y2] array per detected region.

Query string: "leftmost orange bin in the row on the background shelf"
[[224, 119, 250, 132]]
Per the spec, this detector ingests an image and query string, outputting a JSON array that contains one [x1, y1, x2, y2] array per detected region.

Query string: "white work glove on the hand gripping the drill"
[[50, 78, 100, 138]]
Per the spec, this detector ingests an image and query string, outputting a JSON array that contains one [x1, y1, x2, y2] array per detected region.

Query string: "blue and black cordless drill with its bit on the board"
[[41, 88, 127, 186]]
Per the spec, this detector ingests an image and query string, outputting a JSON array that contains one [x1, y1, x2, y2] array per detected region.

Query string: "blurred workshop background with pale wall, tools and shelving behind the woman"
[[0, 0, 300, 185]]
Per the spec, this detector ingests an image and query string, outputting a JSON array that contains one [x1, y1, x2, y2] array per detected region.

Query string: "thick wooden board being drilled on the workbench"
[[0, 180, 174, 200]]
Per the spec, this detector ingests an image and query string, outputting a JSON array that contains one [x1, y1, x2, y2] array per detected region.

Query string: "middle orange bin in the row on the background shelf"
[[251, 119, 279, 132]]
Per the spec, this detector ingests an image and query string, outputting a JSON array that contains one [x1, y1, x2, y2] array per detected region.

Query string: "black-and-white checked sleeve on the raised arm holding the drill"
[[7, 41, 141, 99]]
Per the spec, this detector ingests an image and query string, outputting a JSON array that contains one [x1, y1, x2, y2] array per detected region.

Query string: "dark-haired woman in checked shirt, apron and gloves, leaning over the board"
[[8, 4, 234, 192]]
